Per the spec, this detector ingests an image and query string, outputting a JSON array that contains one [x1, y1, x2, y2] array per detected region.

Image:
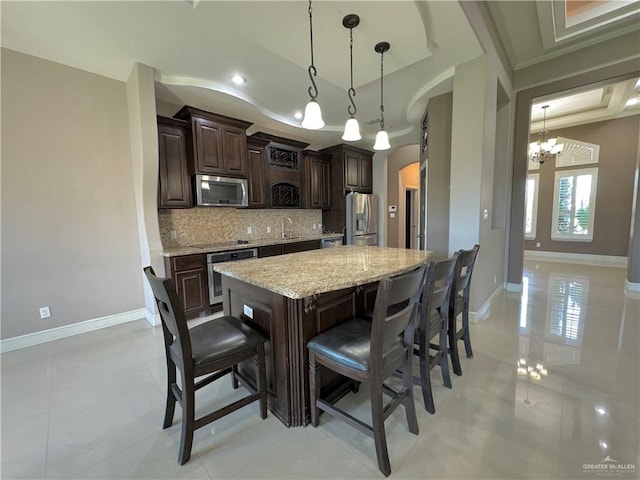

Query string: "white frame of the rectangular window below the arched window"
[[551, 167, 598, 242]]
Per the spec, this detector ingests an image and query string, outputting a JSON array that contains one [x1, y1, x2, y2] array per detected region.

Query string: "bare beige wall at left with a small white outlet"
[[1, 49, 143, 339]]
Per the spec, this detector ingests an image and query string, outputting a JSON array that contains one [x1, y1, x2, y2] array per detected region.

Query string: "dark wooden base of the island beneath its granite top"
[[222, 275, 377, 427]]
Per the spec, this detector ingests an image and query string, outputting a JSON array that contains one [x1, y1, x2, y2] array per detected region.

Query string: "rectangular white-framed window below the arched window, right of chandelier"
[[551, 168, 598, 242]]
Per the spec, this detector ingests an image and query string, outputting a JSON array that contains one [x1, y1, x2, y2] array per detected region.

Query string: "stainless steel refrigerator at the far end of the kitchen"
[[346, 193, 378, 245]]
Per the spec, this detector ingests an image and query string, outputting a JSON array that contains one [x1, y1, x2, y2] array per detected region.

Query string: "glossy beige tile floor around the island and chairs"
[[0, 263, 640, 479]]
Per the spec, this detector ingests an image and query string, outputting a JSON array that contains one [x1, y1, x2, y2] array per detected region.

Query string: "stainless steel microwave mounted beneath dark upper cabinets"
[[196, 175, 249, 207]]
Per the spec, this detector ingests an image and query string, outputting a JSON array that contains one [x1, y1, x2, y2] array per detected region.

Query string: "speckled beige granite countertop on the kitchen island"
[[213, 245, 432, 299]]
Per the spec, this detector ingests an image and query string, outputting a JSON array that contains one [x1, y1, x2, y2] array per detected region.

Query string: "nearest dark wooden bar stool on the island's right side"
[[307, 266, 425, 476]]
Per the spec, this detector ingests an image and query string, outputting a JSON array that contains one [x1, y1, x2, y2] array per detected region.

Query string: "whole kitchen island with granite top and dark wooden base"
[[214, 245, 432, 426]]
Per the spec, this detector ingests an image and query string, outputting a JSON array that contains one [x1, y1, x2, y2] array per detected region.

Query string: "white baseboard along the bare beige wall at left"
[[0, 308, 148, 353]]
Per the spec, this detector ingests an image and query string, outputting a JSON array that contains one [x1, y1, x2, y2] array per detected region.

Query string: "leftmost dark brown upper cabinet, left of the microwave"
[[158, 117, 193, 208]]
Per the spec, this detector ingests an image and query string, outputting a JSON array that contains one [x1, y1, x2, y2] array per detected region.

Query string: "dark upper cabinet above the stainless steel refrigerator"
[[321, 144, 373, 194]]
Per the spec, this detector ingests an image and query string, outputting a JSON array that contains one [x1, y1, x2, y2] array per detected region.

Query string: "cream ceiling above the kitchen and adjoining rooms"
[[0, 0, 640, 149]]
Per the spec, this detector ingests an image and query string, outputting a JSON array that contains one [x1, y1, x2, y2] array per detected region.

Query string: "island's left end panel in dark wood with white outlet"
[[222, 275, 292, 427]]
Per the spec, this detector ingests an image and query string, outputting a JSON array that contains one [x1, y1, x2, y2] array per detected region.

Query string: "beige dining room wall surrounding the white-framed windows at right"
[[524, 115, 640, 257]]
